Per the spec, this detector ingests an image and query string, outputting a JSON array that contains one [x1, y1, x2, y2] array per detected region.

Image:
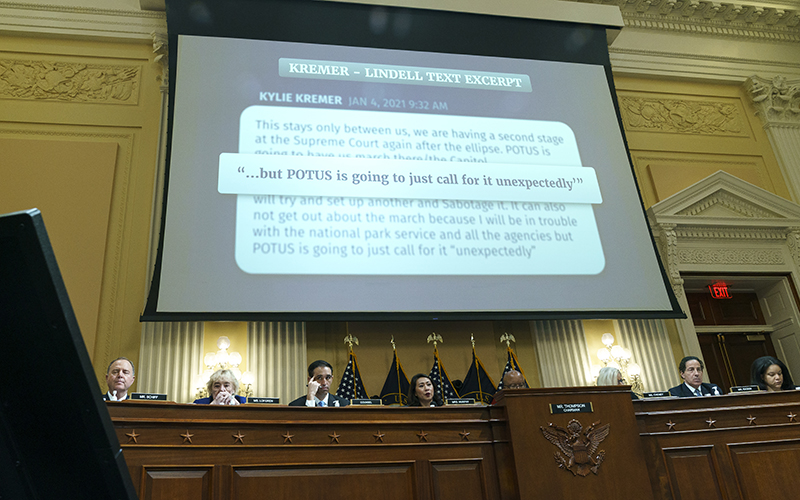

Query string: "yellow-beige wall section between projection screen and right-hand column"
[[615, 76, 790, 208]]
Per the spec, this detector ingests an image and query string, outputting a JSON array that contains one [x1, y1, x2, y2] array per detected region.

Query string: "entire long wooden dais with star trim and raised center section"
[[108, 386, 800, 500]]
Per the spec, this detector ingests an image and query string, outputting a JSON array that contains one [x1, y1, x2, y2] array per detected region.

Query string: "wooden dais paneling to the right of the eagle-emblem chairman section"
[[633, 391, 800, 500]]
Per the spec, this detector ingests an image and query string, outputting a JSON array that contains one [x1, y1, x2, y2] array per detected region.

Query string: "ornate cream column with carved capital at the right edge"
[[745, 75, 800, 203]]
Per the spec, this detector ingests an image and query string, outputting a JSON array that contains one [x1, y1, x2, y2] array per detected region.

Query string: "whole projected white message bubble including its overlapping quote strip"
[[231, 106, 605, 275]]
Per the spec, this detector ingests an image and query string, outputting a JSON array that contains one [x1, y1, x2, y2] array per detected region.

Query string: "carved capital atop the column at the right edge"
[[745, 75, 800, 126]]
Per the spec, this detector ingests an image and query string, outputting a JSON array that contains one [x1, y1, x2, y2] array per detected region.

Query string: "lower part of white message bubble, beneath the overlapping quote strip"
[[236, 195, 605, 275]]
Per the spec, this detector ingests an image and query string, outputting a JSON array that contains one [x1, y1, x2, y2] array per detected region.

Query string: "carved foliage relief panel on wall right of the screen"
[[619, 95, 747, 136]]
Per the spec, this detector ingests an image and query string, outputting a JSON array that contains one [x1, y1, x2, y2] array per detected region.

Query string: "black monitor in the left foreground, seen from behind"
[[0, 209, 137, 499]]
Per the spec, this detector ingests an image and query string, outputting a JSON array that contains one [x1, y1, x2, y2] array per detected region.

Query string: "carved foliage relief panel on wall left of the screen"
[[0, 59, 142, 105]]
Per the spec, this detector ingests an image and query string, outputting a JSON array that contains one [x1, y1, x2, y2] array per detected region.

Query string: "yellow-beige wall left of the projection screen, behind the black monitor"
[[0, 35, 161, 390]]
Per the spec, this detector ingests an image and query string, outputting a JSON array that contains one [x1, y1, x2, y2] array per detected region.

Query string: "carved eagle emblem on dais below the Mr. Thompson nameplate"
[[539, 419, 611, 477]]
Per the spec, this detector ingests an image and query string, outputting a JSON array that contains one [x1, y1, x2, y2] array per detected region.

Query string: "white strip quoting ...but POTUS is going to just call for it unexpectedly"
[[217, 153, 603, 203]]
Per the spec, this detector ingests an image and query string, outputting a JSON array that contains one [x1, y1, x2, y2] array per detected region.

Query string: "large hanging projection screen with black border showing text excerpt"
[[142, 0, 682, 320]]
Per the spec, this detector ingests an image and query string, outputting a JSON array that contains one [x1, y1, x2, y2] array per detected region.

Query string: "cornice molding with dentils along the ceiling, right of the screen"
[[570, 0, 800, 43]]
